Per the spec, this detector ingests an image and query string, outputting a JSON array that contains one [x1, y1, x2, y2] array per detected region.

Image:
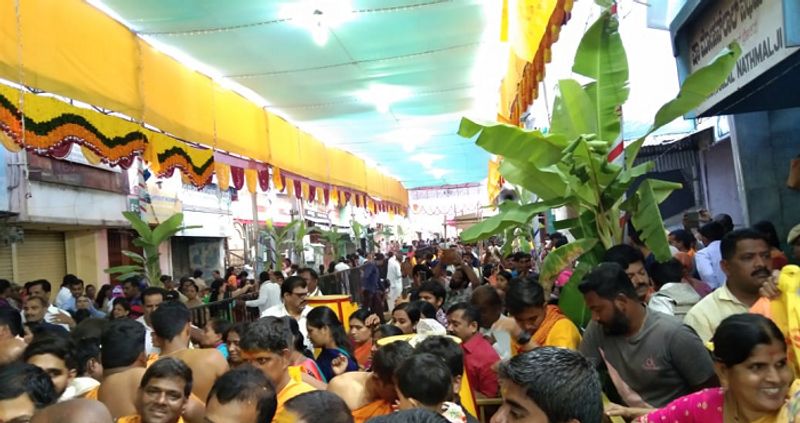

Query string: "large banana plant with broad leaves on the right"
[[459, 8, 741, 326]]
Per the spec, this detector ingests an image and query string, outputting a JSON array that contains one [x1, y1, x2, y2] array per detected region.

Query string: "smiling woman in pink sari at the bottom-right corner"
[[636, 314, 796, 423]]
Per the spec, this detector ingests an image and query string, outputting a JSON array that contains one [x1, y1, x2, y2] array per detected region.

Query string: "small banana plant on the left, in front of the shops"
[[105, 212, 201, 285]]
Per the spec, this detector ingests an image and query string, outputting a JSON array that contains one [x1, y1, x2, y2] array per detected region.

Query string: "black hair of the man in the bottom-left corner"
[[0, 361, 58, 409]]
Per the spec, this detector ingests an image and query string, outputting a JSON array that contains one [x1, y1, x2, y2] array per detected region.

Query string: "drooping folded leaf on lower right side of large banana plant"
[[631, 179, 681, 262]]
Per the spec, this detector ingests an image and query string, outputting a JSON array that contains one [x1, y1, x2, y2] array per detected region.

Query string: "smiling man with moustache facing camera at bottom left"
[[117, 357, 192, 423]]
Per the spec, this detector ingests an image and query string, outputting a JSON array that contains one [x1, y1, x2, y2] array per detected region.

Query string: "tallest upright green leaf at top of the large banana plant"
[[572, 11, 630, 143]]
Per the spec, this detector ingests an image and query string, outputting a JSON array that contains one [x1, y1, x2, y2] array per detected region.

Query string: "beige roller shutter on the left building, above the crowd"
[[14, 231, 67, 288]]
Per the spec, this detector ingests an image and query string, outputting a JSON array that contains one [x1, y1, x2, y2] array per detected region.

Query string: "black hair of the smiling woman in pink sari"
[[711, 313, 786, 367]]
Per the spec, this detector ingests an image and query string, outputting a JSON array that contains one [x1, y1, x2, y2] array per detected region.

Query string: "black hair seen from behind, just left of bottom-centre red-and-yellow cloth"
[[395, 353, 453, 407]]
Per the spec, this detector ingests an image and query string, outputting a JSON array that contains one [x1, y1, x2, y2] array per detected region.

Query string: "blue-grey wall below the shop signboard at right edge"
[[733, 108, 800, 242]]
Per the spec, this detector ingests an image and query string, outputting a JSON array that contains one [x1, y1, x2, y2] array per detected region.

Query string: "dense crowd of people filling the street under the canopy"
[[0, 215, 800, 423]]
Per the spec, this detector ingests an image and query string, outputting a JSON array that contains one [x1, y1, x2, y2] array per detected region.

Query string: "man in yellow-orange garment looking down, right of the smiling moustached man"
[[239, 317, 315, 421]]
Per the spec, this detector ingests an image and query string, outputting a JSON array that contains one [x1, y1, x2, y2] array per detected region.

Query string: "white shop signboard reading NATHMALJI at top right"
[[684, 0, 800, 114]]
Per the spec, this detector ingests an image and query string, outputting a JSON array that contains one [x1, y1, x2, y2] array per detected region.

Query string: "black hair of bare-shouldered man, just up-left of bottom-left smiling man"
[[100, 319, 146, 369]]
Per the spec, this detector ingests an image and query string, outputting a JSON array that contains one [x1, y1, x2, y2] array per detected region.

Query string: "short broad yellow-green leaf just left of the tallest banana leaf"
[[550, 79, 597, 140]]
